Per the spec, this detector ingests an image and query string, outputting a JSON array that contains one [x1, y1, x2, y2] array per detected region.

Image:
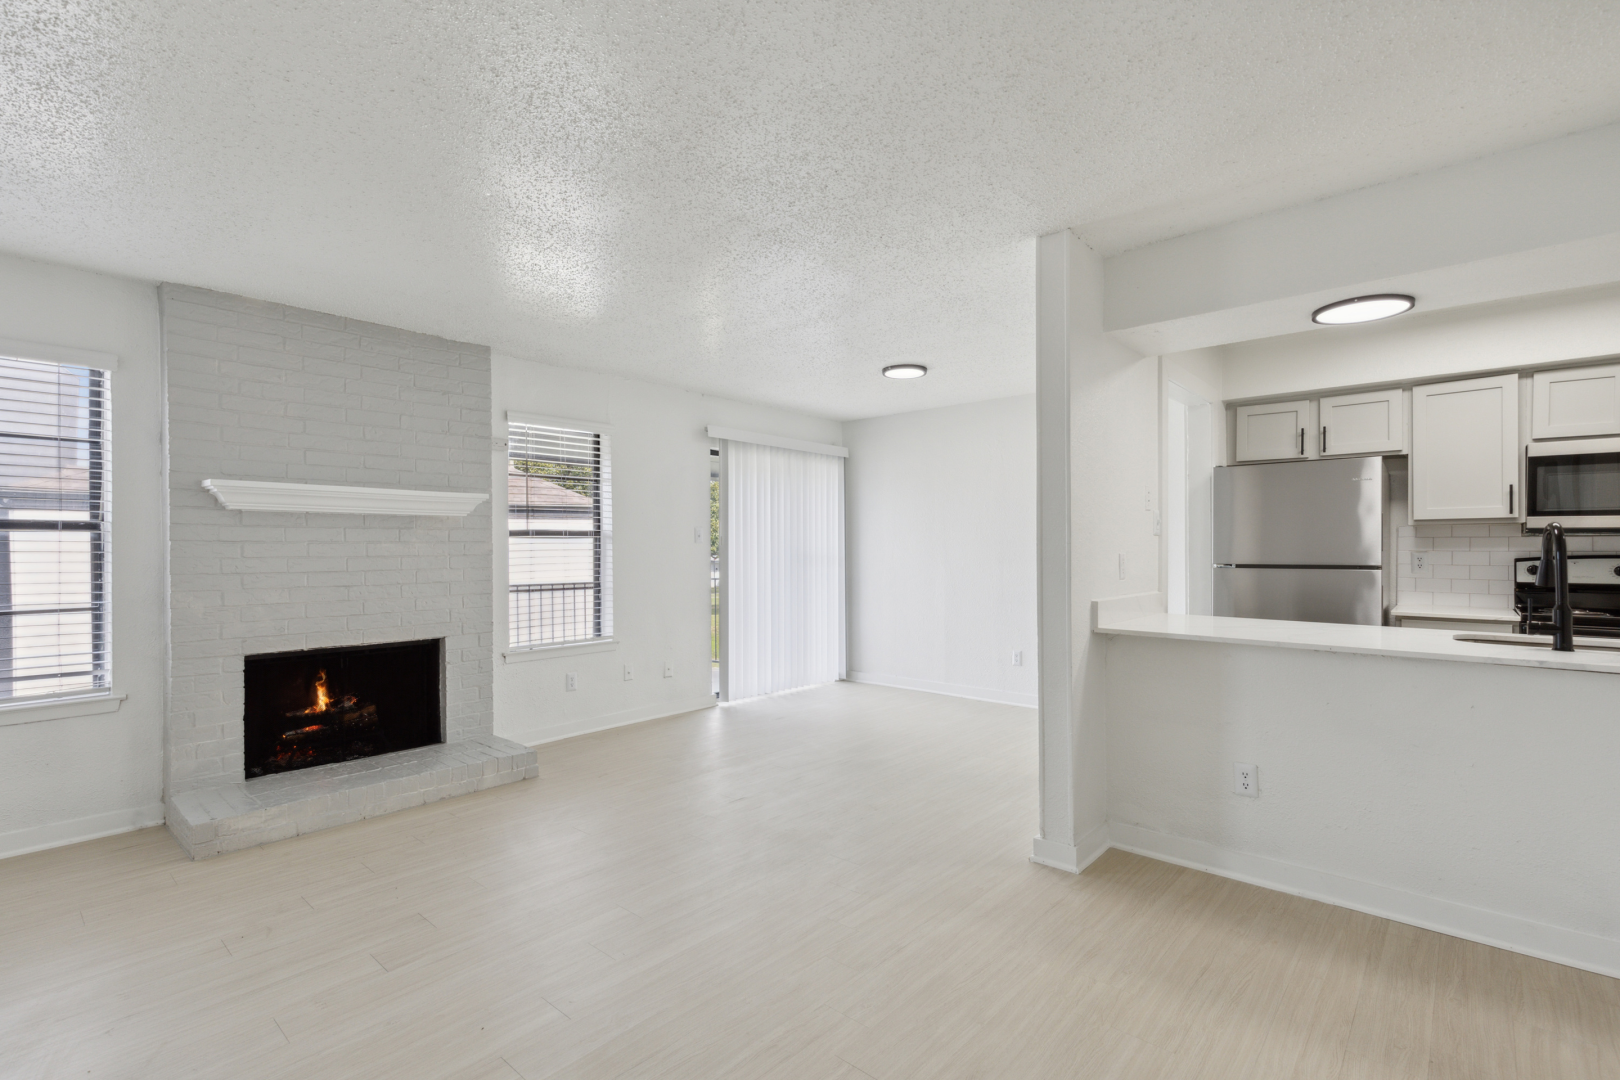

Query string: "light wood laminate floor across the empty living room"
[[0, 683, 1620, 1080]]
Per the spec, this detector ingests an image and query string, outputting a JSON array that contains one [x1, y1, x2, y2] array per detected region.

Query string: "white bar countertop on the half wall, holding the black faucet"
[[1092, 601, 1620, 675]]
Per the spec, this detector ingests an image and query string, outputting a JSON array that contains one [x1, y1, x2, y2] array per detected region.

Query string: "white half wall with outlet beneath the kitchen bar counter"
[[1108, 638, 1620, 975]]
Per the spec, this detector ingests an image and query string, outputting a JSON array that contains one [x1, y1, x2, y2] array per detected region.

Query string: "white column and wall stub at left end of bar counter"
[[1034, 230, 1160, 873]]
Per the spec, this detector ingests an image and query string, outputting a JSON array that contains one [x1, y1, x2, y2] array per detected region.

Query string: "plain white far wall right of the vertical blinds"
[[844, 395, 1037, 706]]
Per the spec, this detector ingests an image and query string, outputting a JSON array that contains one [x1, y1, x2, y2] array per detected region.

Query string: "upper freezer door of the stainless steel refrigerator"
[[1215, 458, 1383, 567]]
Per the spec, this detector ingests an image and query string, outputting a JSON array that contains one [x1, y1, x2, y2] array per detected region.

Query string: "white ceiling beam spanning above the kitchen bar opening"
[[1103, 125, 1620, 353]]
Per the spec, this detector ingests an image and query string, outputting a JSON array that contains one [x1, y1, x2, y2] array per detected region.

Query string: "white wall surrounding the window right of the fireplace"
[[491, 353, 841, 745]]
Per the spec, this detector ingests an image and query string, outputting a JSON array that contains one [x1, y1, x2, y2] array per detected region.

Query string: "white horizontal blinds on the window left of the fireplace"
[[0, 356, 109, 698]]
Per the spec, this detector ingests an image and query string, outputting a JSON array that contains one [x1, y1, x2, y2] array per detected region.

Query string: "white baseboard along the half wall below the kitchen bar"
[[1108, 823, 1620, 978]]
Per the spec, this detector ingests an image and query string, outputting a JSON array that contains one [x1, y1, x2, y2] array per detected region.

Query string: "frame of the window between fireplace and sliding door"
[[501, 411, 617, 659]]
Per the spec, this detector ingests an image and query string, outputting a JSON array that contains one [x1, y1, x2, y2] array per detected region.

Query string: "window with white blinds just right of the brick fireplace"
[[507, 419, 612, 649]]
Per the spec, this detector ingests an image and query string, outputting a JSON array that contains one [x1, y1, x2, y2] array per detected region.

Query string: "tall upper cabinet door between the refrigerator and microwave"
[[1411, 374, 1523, 521]]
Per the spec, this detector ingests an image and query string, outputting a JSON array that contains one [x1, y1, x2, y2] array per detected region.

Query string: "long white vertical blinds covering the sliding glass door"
[[721, 440, 844, 701]]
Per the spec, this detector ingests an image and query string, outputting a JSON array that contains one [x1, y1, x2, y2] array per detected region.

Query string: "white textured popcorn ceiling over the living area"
[[9, 0, 1620, 418]]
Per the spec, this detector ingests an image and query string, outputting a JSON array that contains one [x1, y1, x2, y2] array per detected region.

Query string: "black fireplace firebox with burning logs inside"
[[243, 640, 444, 780]]
